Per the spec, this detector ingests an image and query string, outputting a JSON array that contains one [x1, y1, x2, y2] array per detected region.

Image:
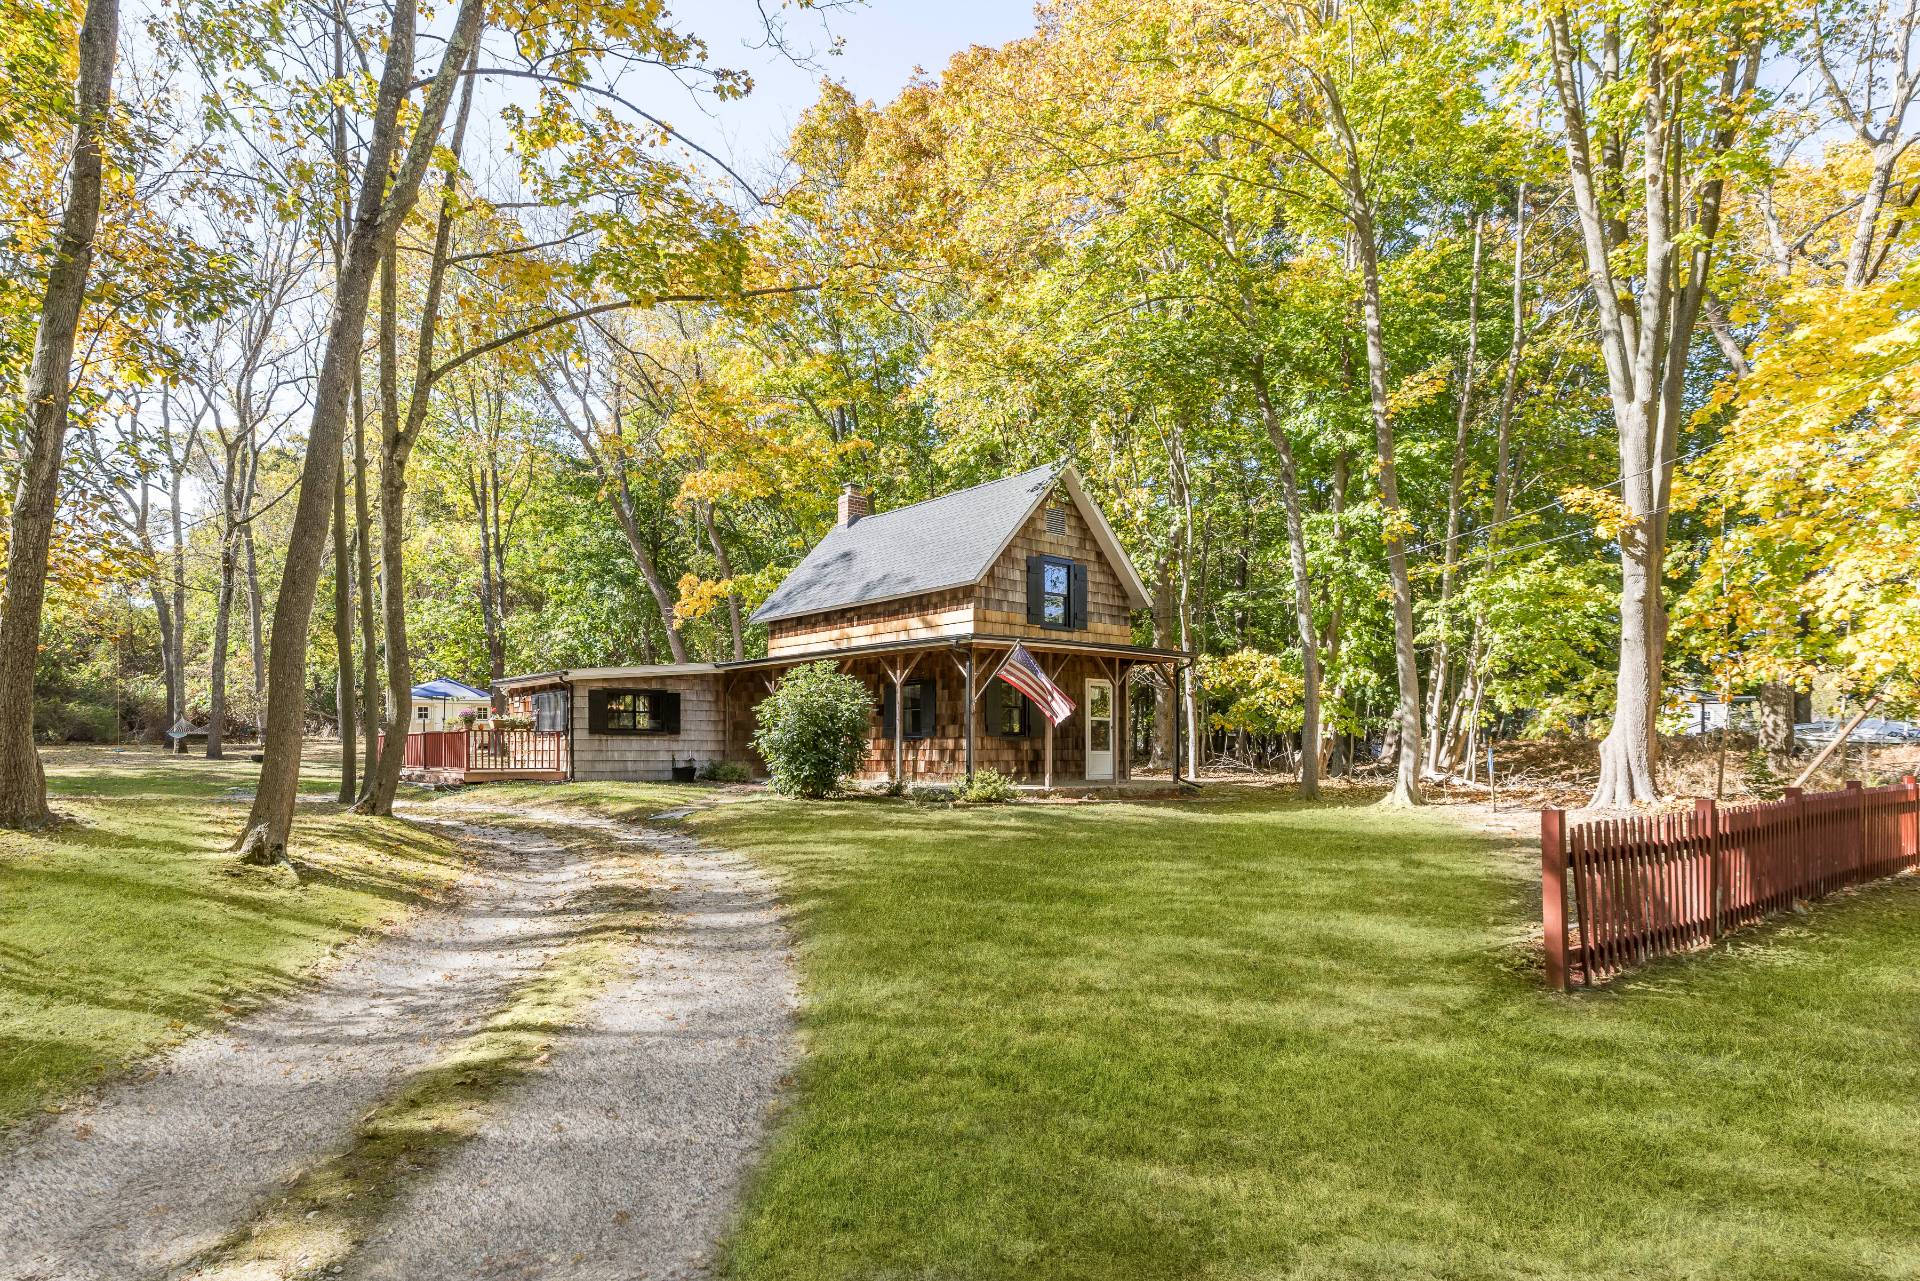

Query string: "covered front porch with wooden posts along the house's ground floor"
[[722, 636, 1190, 793]]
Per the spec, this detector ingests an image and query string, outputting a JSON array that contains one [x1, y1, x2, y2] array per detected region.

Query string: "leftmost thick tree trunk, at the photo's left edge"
[[0, 0, 119, 828]]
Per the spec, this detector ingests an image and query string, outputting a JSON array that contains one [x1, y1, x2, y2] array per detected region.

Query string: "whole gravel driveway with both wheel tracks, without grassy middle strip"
[[0, 814, 795, 1281]]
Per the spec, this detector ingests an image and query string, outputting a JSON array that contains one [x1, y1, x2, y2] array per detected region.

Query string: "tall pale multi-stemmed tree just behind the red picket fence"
[[1544, 0, 1770, 807]]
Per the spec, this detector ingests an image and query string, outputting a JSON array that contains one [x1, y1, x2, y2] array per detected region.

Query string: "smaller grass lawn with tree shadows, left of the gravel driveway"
[[0, 747, 461, 1125]]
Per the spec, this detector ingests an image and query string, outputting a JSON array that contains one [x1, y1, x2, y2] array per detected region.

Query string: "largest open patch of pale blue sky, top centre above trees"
[[637, 0, 1033, 184]]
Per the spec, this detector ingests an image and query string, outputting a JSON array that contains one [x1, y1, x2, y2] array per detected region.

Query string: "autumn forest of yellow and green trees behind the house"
[[0, 0, 1920, 841]]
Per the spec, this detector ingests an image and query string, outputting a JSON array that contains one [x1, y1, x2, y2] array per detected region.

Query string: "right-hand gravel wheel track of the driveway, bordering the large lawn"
[[346, 810, 797, 1281]]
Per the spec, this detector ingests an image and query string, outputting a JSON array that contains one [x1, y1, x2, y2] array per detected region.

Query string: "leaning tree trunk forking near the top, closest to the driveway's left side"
[[238, 0, 484, 862]]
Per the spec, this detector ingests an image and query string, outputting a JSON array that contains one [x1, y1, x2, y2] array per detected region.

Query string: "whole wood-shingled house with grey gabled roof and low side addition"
[[487, 463, 1192, 787]]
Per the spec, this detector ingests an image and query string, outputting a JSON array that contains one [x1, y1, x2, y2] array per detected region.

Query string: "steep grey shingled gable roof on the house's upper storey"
[[753, 461, 1150, 622]]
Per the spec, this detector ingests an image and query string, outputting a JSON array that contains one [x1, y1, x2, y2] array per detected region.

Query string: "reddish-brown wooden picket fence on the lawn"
[[1540, 774, 1920, 991]]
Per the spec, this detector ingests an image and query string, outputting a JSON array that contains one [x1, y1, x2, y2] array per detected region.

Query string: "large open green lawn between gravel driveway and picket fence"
[[689, 797, 1920, 1281]]
